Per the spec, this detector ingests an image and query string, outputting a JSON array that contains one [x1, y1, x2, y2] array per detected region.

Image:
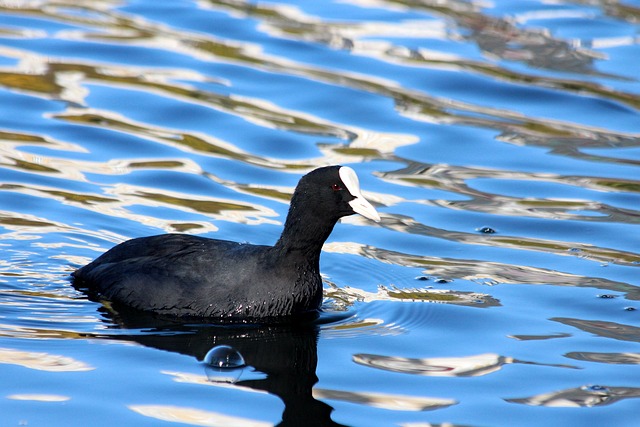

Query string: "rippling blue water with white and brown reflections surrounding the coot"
[[0, 0, 640, 427]]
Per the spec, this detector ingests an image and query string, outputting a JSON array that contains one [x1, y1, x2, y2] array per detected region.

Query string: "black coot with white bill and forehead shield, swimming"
[[72, 166, 380, 321]]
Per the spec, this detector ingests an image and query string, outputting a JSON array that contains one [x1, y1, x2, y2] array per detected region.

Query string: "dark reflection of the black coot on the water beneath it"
[[94, 307, 350, 427]]
